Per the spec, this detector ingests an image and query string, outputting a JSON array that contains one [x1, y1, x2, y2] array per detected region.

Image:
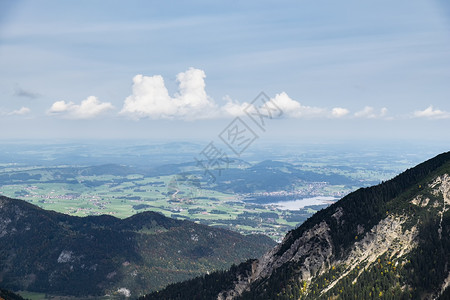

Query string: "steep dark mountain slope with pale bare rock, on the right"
[[144, 152, 450, 299]]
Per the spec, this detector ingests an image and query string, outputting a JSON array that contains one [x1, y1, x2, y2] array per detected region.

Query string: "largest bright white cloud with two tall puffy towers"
[[121, 68, 217, 120]]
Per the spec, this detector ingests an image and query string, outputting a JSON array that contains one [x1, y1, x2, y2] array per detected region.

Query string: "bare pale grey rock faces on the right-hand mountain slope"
[[218, 174, 450, 300]]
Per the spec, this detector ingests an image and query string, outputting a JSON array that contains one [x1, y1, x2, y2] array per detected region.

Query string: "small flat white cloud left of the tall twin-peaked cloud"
[[48, 96, 114, 119]]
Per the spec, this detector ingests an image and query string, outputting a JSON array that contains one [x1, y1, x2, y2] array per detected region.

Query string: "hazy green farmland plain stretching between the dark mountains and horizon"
[[0, 144, 440, 240]]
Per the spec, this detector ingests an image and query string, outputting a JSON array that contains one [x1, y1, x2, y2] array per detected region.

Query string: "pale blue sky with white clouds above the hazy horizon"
[[0, 0, 450, 143]]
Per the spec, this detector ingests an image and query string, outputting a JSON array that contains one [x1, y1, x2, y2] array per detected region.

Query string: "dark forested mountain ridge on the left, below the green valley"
[[0, 197, 275, 296]]
